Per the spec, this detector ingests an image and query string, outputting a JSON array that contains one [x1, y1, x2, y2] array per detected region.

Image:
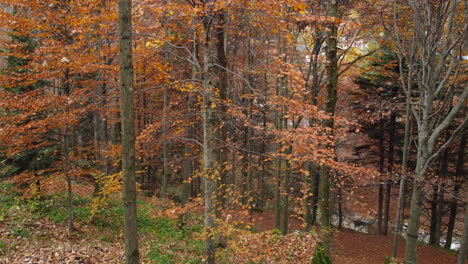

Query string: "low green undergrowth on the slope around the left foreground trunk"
[[0, 182, 204, 264]]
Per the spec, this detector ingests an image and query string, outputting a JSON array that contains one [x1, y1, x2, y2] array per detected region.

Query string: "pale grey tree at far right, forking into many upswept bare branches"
[[390, 1, 468, 264]]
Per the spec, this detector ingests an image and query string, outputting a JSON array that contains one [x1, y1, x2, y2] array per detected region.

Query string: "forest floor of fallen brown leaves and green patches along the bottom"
[[0, 182, 456, 264]]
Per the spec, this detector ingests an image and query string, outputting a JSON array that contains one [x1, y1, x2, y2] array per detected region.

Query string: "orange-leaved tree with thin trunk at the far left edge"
[[1, 1, 107, 231]]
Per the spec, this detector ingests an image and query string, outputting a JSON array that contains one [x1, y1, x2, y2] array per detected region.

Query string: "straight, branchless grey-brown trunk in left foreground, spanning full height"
[[118, 0, 140, 264]]
